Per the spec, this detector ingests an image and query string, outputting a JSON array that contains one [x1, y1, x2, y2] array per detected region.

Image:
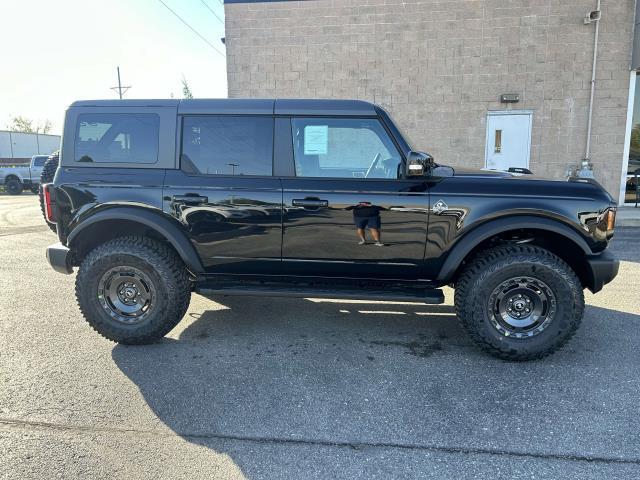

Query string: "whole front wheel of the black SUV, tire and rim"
[[455, 245, 584, 360]]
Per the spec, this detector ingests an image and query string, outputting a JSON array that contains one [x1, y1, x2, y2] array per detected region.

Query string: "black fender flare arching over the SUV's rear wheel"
[[67, 206, 204, 273]]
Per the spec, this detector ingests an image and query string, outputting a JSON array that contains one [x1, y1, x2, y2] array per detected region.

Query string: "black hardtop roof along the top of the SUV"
[[71, 98, 376, 116]]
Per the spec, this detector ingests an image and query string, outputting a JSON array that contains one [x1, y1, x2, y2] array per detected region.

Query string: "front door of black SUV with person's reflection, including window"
[[282, 117, 429, 278]]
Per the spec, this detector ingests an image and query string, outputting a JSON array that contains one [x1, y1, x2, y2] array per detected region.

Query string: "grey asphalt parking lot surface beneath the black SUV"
[[0, 194, 640, 479]]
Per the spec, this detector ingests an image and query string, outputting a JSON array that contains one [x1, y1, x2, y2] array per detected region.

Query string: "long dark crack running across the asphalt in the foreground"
[[0, 418, 640, 465]]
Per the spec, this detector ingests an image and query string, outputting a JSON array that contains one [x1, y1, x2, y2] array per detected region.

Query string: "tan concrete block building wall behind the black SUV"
[[225, 0, 635, 198]]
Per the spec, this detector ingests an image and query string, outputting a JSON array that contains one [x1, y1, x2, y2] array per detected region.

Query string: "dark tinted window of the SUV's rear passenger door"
[[180, 115, 273, 176]]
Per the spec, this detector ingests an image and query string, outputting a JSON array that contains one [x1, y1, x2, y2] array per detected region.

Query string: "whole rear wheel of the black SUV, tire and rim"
[[76, 237, 191, 344]]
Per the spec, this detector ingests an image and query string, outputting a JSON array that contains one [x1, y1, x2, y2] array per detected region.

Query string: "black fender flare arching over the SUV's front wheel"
[[437, 215, 593, 284]]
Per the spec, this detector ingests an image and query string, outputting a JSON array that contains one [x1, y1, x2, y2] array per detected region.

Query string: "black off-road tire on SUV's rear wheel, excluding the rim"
[[76, 237, 191, 345]]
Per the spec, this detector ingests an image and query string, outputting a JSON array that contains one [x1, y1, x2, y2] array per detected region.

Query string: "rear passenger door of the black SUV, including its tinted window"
[[163, 115, 282, 274]]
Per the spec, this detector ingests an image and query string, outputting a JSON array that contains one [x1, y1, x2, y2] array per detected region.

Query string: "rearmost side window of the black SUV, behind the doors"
[[75, 113, 160, 163]]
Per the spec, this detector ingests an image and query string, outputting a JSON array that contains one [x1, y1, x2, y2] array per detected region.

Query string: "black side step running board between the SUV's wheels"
[[196, 284, 444, 305]]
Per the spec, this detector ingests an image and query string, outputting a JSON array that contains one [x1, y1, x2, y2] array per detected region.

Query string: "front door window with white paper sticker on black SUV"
[[291, 118, 401, 178]]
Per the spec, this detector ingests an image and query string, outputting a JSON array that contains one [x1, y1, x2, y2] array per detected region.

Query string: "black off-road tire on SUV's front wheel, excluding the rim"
[[454, 245, 584, 361]]
